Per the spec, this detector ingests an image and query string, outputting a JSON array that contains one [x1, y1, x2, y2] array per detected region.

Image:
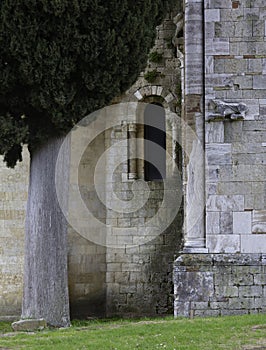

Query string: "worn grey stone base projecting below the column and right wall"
[[173, 254, 266, 317]]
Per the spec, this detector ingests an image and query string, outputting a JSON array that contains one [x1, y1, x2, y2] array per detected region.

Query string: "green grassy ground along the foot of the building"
[[0, 315, 266, 350]]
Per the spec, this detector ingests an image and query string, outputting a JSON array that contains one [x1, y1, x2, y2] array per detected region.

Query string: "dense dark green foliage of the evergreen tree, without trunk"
[[0, 0, 174, 166]]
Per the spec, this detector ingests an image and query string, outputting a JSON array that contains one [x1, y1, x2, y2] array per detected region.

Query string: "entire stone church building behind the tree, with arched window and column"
[[0, 0, 266, 319]]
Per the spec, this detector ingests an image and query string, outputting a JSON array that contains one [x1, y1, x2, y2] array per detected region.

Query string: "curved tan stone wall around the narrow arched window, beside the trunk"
[[66, 91, 182, 318]]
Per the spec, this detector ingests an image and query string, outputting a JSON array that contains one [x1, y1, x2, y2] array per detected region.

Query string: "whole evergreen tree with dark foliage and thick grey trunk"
[[0, 0, 174, 326]]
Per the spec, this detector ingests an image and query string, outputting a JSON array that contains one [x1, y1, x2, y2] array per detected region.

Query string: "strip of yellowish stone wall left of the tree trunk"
[[0, 149, 29, 319]]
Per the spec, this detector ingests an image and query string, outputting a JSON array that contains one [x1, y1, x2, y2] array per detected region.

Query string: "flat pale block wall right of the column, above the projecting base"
[[205, 0, 266, 253]]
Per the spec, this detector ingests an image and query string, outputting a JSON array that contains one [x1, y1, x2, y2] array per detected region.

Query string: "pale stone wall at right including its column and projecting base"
[[174, 0, 266, 317]]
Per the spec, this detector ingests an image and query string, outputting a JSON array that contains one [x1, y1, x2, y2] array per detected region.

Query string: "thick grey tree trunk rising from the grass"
[[22, 138, 70, 327]]
